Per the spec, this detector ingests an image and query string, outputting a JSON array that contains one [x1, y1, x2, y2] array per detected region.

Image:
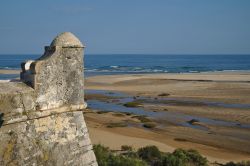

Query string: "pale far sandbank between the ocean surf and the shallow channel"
[[86, 72, 250, 104]]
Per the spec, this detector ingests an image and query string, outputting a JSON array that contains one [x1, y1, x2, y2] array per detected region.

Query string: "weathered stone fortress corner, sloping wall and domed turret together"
[[0, 32, 97, 166]]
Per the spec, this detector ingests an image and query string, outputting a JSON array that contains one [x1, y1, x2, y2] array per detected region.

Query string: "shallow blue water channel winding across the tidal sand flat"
[[86, 90, 250, 130]]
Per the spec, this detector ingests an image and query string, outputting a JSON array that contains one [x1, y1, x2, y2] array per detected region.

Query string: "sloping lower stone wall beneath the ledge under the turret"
[[0, 111, 96, 166]]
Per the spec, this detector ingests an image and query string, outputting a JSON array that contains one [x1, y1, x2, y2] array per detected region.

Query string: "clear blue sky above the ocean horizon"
[[0, 0, 250, 54]]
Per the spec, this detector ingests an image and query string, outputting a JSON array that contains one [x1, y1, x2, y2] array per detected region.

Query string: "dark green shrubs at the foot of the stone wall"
[[94, 145, 209, 166]]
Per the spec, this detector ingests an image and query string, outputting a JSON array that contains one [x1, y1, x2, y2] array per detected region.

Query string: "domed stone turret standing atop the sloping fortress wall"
[[21, 32, 84, 110]]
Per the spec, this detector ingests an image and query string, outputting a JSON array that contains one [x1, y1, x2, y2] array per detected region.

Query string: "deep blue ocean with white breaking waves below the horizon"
[[0, 54, 250, 79]]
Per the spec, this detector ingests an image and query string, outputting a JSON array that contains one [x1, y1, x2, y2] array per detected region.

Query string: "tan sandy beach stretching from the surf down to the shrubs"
[[85, 72, 250, 163]]
